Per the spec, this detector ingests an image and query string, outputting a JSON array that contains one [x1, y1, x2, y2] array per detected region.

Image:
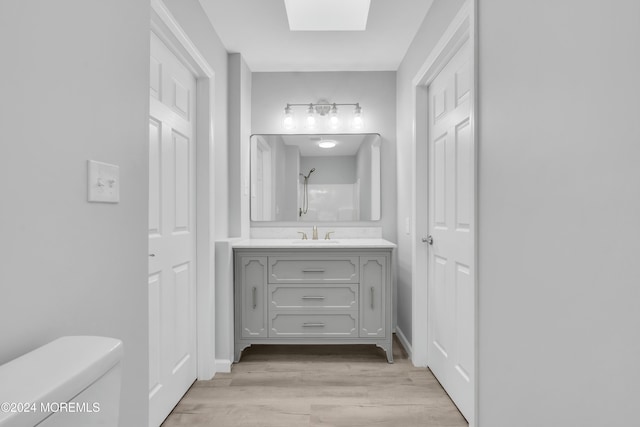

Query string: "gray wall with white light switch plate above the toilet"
[[0, 0, 150, 427]]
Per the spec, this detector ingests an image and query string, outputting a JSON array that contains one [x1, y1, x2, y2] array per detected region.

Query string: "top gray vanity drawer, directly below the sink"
[[269, 257, 360, 283]]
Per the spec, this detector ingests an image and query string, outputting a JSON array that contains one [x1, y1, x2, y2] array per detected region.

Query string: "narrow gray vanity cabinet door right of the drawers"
[[360, 256, 387, 338]]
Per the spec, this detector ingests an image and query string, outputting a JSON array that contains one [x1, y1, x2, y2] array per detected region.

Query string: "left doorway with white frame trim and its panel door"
[[149, 0, 216, 427]]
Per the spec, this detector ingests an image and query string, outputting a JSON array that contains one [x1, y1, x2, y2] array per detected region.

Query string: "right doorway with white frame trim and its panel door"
[[412, 0, 478, 426]]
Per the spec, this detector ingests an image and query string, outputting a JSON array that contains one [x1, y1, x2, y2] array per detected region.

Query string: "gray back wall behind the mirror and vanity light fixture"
[[251, 71, 397, 242]]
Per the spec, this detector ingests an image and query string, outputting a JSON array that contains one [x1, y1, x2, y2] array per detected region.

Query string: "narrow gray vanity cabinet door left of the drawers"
[[239, 256, 267, 338]]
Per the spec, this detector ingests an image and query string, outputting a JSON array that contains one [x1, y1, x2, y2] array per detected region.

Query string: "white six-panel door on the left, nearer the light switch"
[[149, 33, 196, 427]]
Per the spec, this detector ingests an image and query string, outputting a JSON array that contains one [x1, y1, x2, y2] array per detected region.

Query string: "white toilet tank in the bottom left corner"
[[0, 337, 123, 427]]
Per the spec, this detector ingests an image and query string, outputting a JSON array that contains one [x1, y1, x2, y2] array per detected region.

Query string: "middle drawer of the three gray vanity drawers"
[[269, 283, 358, 310]]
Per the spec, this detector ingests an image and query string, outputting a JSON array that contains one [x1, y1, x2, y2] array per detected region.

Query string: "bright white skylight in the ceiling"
[[284, 0, 371, 31]]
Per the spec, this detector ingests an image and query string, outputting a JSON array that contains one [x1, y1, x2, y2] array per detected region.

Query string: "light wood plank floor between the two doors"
[[162, 341, 468, 427]]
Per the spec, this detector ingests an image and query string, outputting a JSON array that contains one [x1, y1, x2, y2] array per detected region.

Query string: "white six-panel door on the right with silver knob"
[[427, 42, 475, 421]]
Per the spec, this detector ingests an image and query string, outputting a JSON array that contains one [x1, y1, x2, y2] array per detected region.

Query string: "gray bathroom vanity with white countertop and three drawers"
[[234, 239, 395, 363]]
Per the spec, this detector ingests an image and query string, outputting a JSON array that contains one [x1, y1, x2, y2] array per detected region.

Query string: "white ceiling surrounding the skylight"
[[200, 0, 433, 72]]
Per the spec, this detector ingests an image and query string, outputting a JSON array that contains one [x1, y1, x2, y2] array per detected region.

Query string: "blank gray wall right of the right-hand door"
[[478, 0, 640, 427]]
